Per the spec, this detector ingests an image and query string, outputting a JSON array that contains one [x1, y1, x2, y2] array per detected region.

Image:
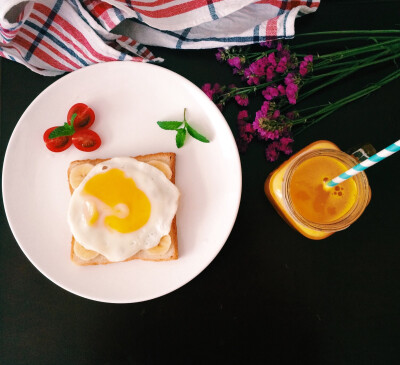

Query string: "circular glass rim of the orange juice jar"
[[282, 148, 370, 232]]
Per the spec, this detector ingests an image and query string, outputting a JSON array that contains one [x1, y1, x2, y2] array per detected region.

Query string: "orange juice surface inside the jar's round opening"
[[289, 156, 357, 224]]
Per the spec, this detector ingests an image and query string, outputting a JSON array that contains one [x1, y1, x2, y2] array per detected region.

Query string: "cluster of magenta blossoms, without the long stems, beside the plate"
[[202, 42, 313, 161]]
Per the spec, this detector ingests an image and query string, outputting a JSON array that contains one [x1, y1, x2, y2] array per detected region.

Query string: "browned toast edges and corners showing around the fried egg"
[[68, 152, 178, 265]]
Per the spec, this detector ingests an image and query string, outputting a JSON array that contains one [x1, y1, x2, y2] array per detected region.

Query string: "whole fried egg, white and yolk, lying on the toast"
[[68, 157, 180, 262]]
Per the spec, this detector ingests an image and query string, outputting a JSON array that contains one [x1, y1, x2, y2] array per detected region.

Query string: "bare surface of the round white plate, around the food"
[[3, 62, 242, 303]]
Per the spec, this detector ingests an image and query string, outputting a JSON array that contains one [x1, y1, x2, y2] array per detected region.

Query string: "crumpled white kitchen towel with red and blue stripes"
[[0, 0, 319, 76]]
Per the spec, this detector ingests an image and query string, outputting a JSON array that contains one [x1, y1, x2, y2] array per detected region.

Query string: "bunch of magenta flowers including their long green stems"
[[202, 30, 400, 161]]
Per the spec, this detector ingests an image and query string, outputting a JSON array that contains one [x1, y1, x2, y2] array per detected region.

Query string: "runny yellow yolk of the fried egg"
[[83, 169, 151, 233]]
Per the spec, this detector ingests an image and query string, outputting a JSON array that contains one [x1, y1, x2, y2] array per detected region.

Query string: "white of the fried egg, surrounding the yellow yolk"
[[68, 157, 180, 262]]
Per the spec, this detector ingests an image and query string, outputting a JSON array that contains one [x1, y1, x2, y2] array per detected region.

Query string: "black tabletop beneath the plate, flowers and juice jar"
[[0, 0, 400, 365]]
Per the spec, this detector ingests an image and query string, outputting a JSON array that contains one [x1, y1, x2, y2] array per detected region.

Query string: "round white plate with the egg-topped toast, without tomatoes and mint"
[[2, 62, 242, 303]]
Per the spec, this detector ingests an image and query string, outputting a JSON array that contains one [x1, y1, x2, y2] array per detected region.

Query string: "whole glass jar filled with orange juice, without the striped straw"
[[264, 141, 371, 240]]
